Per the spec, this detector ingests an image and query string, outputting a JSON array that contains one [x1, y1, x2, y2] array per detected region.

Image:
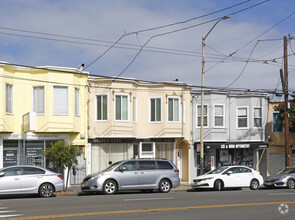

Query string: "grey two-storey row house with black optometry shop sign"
[[191, 91, 269, 176]]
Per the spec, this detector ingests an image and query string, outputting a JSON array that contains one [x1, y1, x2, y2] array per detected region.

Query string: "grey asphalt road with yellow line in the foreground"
[[0, 189, 295, 220]]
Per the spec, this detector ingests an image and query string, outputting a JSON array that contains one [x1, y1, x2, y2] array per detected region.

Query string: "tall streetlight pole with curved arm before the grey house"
[[200, 16, 230, 174]]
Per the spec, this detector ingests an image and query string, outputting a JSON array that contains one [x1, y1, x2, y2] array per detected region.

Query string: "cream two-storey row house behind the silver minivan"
[[87, 77, 190, 182]]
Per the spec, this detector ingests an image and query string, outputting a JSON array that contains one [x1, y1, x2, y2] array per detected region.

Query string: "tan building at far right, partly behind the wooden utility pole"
[[267, 101, 295, 175]]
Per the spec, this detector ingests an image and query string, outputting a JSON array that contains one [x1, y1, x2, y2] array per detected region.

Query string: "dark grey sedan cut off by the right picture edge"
[[264, 168, 295, 189]]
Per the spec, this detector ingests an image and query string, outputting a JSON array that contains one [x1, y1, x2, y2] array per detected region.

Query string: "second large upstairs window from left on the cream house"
[[115, 95, 129, 121]]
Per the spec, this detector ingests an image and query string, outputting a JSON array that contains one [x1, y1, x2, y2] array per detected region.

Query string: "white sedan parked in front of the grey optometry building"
[[191, 166, 263, 191]]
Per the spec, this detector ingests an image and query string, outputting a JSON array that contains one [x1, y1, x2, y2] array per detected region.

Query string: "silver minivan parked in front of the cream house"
[[81, 159, 180, 194]]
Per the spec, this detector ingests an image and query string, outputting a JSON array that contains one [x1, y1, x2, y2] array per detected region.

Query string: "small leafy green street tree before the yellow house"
[[43, 141, 81, 190]]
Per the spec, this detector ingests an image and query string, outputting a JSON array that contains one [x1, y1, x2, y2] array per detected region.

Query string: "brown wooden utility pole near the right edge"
[[280, 36, 291, 168]]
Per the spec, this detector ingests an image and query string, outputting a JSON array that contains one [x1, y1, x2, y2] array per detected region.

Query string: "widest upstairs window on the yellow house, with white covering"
[[53, 86, 69, 115]]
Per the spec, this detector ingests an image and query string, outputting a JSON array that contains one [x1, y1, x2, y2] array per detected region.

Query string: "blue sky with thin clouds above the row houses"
[[0, 0, 295, 98]]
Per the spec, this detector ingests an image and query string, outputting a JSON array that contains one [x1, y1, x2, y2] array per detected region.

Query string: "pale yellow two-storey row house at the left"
[[0, 62, 88, 183]]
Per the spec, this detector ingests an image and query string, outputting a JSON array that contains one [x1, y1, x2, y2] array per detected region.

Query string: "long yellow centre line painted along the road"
[[13, 201, 295, 220]]
